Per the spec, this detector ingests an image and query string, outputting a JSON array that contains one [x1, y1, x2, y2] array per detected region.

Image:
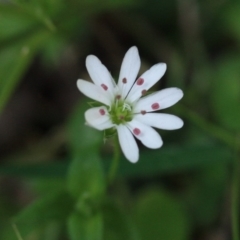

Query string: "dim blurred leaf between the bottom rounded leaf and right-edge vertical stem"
[[183, 163, 230, 226]]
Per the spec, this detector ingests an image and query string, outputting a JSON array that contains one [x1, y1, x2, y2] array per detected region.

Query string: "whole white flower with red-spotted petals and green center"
[[77, 47, 183, 163]]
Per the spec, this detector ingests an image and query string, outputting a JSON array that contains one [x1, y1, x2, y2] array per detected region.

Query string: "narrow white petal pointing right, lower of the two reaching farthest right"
[[134, 113, 183, 130]]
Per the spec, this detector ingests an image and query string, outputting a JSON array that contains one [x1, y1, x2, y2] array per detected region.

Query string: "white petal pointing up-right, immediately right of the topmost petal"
[[127, 63, 167, 102]]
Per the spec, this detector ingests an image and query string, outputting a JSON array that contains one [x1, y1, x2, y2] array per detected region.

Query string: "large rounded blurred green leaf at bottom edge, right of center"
[[134, 190, 190, 240]]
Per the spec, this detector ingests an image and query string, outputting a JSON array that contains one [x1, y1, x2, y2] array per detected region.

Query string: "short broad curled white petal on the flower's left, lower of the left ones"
[[85, 106, 114, 130]]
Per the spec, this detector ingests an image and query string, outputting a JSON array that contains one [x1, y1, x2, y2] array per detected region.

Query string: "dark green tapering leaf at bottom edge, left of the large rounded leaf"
[[102, 200, 140, 240]]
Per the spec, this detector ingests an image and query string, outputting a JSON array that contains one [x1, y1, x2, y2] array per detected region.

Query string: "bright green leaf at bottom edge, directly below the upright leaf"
[[68, 212, 103, 240]]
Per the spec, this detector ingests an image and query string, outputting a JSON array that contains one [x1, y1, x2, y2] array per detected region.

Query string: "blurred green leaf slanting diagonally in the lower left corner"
[[13, 192, 73, 237]]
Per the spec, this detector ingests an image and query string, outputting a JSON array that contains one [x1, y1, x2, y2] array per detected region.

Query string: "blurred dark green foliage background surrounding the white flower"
[[0, 0, 240, 240]]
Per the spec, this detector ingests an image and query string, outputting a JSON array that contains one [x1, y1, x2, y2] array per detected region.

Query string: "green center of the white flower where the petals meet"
[[109, 98, 133, 125]]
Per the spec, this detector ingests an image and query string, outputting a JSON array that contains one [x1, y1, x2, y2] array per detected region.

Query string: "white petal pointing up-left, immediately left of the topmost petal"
[[86, 55, 114, 97]]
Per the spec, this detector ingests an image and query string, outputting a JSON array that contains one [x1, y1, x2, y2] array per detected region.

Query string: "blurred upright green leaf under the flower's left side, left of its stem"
[[67, 99, 106, 202]]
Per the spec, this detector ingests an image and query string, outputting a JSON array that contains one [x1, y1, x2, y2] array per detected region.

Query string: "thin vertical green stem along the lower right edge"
[[231, 136, 240, 240]]
